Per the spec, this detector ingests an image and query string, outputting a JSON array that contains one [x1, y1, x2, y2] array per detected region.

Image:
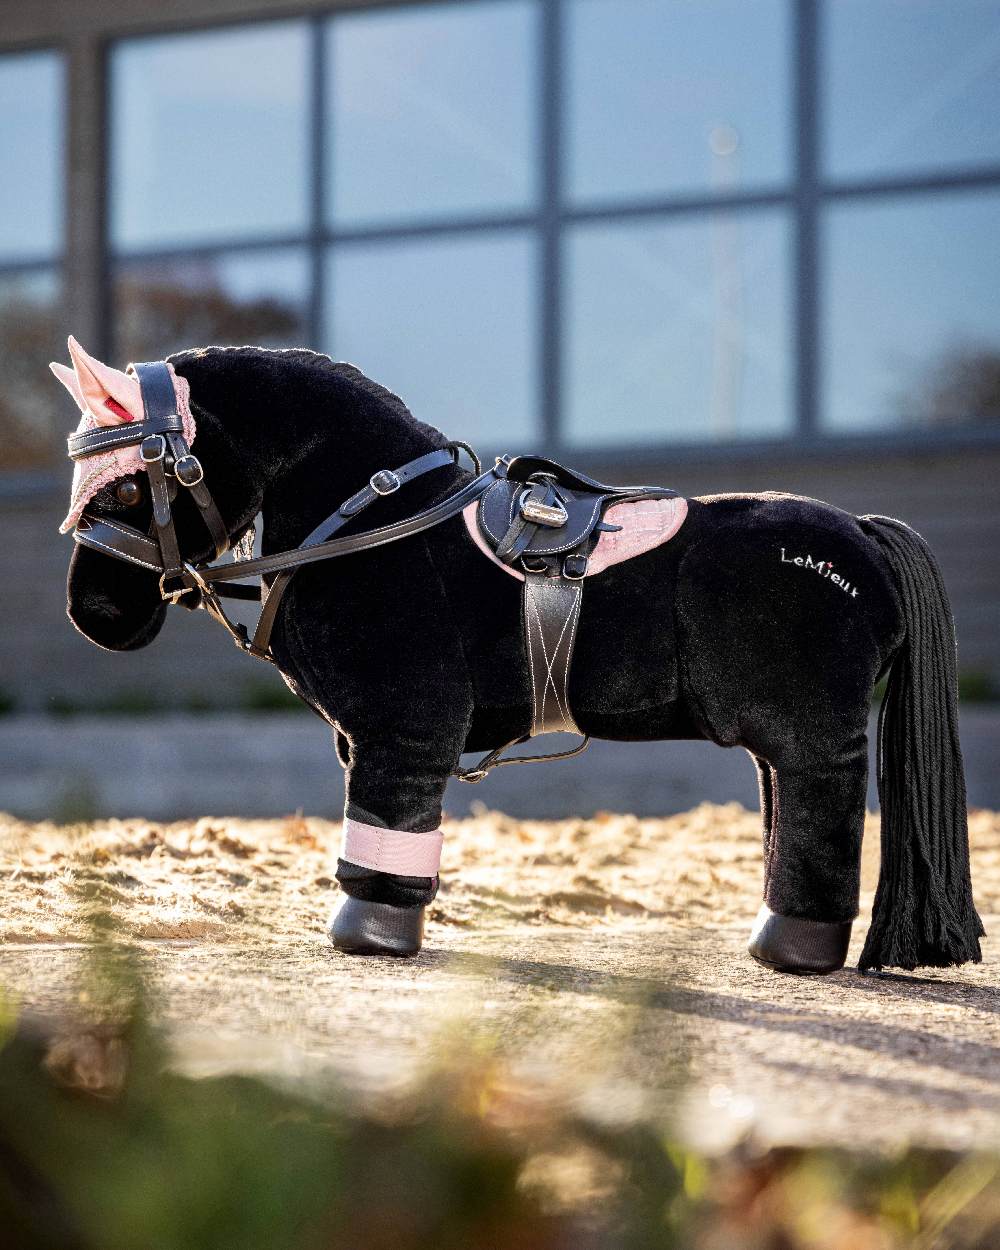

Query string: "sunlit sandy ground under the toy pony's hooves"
[[0, 804, 1000, 1148]]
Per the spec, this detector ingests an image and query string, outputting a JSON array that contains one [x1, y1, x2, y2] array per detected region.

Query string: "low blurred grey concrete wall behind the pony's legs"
[[0, 708, 1000, 821]]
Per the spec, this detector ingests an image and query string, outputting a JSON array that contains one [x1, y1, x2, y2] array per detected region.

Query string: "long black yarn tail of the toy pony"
[[859, 516, 985, 969]]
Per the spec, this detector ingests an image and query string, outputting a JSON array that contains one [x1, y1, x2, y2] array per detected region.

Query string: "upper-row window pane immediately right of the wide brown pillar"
[[111, 23, 309, 248]]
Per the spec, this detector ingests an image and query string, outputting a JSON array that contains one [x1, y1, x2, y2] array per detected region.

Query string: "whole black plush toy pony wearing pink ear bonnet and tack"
[[53, 340, 983, 973]]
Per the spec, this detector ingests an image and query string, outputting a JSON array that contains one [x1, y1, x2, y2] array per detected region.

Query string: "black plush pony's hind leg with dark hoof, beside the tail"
[[749, 738, 868, 975]]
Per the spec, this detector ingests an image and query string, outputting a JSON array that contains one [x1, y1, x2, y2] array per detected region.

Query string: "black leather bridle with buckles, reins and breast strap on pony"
[[69, 360, 492, 663]]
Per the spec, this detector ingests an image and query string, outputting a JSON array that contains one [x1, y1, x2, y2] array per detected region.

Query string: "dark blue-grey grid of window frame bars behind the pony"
[[86, 0, 1000, 463]]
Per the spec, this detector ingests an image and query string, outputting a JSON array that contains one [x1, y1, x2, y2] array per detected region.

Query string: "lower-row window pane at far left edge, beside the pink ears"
[[0, 269, 63, 470]]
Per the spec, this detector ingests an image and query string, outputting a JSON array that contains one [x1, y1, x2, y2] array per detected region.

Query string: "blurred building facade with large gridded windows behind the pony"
[[0, 0, 1000, 709]]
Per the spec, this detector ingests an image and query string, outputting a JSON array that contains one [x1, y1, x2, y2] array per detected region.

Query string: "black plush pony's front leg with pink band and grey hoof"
[[329, 740, 458, 956]]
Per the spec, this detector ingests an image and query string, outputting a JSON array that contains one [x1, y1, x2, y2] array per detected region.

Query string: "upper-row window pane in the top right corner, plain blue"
[[823, 0, 1000, 178]]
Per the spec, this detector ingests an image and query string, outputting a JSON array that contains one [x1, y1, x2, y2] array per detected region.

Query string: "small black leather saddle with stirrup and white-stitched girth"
[[466, 456, 676, 760]]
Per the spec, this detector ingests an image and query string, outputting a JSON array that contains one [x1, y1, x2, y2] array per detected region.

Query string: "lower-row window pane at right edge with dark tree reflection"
[[823, 193, 1000, 430]]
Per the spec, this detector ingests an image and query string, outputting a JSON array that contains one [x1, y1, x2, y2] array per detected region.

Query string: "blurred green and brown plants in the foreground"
[[0, 919, 1000, 1250]]
